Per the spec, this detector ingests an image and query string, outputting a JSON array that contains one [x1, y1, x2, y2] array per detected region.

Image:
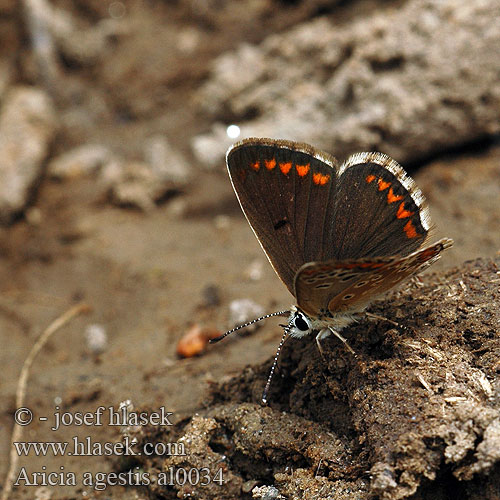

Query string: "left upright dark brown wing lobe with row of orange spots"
[[226, 139, 338, 294]]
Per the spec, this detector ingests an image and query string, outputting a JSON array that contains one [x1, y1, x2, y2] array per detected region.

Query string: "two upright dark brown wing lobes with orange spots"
[[226, 139, 440, 300]]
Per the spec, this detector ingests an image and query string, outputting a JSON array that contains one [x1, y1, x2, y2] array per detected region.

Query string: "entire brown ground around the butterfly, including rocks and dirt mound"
[[0, 0, 500, 500]]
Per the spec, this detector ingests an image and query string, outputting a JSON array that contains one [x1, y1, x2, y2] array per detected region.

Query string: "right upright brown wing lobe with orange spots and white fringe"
[[326, 153, 430, 260]]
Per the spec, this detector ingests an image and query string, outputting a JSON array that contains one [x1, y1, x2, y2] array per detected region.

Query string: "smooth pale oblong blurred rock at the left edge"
[[0, 87, 56, 223]]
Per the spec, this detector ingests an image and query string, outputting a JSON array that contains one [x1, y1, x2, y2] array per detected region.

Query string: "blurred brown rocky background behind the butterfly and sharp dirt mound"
[[0, 0, 500, 498]]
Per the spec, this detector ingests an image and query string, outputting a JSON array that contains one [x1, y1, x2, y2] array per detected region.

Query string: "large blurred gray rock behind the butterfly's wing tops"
[[193, 0, 500, 168]]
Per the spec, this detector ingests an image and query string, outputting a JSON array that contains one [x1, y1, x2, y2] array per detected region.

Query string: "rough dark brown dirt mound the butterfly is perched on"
[[130, 259, 500, 500]]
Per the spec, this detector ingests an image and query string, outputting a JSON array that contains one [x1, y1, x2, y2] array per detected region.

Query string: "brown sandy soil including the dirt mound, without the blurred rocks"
[[0, 1, 500, 499]]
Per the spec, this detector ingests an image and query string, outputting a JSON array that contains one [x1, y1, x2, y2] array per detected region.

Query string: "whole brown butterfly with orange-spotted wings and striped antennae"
[[212, 138, 453, 404]]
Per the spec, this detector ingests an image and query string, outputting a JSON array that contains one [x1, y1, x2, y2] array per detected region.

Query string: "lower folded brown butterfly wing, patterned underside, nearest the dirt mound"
[[295, 239, 453, 317]]
